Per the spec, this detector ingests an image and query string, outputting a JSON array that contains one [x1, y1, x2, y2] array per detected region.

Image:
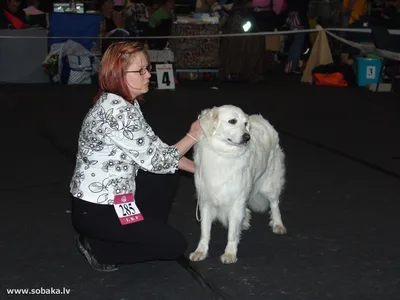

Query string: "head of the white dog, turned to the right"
[[199, 105, 251, 147]]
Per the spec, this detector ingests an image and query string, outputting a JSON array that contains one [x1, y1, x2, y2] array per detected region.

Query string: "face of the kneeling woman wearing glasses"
[[126, 52, 151, 99]]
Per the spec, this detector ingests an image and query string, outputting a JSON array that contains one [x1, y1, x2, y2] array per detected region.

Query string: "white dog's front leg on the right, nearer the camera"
[[221, 207, 244, 264]]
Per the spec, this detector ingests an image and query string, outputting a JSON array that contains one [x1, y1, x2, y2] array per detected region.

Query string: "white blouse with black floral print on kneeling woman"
[[70, 93, 179, 204]]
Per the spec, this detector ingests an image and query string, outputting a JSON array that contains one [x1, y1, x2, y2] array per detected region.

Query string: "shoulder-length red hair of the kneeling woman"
[[94, 42, 150, 103]]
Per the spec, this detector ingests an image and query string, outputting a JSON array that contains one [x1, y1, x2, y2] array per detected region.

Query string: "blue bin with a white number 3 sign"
[[356, 57, 383, 86]]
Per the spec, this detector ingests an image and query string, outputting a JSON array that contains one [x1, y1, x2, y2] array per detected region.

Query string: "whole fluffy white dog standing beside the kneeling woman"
[[190, 105, 286, 264]]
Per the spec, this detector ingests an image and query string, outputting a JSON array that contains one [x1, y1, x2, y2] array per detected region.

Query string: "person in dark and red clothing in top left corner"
[[0, 0, 29, 29]]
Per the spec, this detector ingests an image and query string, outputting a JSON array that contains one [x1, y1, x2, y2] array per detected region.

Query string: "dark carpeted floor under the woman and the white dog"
[[0, 76, 400, 300]]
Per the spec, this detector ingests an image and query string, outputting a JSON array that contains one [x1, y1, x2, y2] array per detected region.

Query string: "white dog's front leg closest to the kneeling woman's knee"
[[189, 205, 215, 261]]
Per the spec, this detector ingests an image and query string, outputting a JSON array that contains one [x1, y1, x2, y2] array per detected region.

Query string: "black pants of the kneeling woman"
[[72, 171, 187, 265]]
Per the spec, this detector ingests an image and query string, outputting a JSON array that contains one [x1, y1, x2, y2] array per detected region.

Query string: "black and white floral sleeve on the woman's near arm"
[[100, 99, 180, 174]]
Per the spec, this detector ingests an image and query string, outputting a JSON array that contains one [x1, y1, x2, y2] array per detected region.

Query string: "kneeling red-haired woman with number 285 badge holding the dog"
[[70, 42, 201, 271]]
